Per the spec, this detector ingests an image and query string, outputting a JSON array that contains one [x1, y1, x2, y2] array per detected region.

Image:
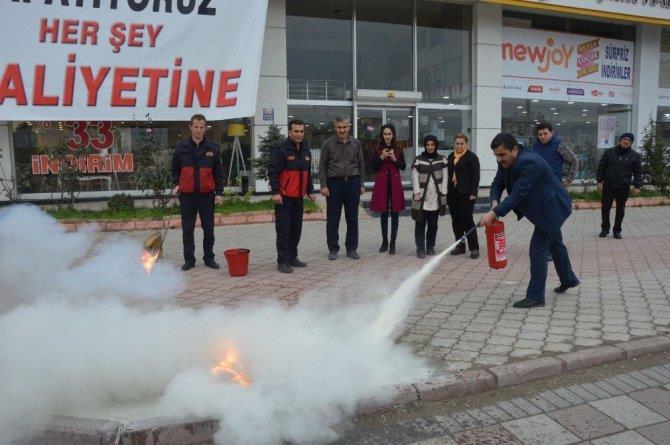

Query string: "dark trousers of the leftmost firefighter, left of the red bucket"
[[179, 194, 214, 264]]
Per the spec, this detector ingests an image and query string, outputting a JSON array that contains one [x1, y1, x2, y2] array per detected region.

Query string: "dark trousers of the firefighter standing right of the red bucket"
[[275, 197, 302, 263]]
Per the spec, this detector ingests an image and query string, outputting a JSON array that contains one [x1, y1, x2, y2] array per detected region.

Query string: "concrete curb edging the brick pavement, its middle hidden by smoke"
[[30, 335, 670, 445]]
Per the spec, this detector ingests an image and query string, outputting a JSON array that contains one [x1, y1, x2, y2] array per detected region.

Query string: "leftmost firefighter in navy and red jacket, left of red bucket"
[[172, 114, 223, 271]]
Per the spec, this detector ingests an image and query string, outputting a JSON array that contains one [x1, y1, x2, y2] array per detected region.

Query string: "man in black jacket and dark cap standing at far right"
[[596, 133, 642, 239]]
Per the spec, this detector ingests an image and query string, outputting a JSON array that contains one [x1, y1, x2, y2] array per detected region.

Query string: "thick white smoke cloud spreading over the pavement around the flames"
[[0, 206, 427, 444]]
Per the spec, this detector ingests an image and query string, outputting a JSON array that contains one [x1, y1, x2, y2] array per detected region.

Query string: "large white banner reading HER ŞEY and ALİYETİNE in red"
[[0, 0, 268, 121]]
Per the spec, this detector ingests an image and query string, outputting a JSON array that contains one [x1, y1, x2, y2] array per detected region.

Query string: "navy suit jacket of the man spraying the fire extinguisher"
[[491, 150, 572, 234]]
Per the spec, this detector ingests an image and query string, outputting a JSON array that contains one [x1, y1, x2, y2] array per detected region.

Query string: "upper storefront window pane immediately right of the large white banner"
[[286, 0, 353, 100]]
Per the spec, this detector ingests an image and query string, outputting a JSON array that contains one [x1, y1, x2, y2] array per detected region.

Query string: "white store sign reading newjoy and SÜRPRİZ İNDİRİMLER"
[[501, 27, 634, 104]]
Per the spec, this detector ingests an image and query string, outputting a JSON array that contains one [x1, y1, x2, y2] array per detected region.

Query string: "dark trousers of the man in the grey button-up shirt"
[[326, 176, 361, 252]]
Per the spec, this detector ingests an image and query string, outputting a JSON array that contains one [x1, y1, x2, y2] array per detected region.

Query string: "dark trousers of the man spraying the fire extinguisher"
[[526, 227, 578, 301]]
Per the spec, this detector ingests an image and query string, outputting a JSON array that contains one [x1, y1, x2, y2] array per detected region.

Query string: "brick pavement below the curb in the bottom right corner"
[[336, 363, 670, 445]]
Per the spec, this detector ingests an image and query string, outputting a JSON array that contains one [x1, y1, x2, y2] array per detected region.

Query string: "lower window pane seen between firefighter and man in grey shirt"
[[288, 105, 353, 184]]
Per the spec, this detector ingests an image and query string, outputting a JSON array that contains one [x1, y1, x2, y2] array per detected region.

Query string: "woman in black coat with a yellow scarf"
[[447, 133, 480, 258]]
